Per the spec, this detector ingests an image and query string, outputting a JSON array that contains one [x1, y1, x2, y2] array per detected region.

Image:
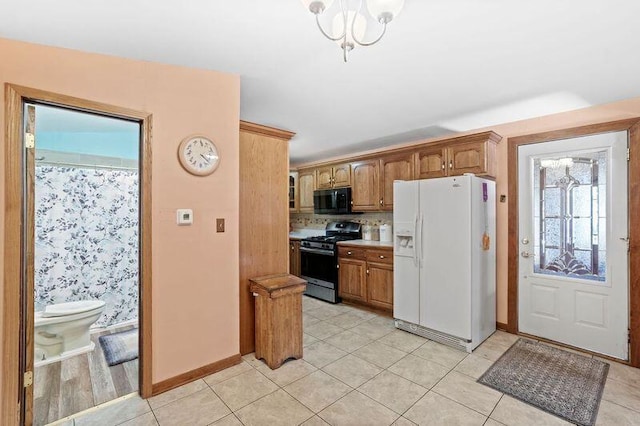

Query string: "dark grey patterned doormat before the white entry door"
[[478, 339, 609, 426]]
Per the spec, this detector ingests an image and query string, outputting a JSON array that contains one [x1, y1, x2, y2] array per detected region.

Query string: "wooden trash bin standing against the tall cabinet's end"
[[249, 274, 307, 370]]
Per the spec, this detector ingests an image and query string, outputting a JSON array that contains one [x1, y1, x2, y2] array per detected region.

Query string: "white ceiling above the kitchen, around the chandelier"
[[0, 0, 640, 164]]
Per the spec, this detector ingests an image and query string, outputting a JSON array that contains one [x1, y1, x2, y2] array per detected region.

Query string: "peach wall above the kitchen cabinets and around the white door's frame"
[[292, 97, 640, 324]]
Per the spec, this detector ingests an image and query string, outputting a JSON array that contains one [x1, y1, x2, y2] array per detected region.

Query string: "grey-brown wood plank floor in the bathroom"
[[33, 326, 138, 426]]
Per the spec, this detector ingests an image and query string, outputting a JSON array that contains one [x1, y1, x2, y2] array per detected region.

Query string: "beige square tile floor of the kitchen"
[[53, 297, 640, 426]]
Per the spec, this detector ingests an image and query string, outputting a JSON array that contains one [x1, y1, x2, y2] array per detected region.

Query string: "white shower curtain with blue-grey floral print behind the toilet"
[[35, 165, 138, 326]]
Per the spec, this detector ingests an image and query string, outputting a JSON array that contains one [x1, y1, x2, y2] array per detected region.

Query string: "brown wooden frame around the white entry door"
[[507, 117, 640, 367]]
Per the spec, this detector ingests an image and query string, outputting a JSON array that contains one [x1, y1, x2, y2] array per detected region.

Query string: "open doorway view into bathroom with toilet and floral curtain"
[[30, 103, 141, 425]]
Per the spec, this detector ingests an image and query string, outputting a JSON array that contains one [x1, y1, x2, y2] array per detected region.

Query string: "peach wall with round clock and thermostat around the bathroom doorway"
[[0, 39, 240, 412]]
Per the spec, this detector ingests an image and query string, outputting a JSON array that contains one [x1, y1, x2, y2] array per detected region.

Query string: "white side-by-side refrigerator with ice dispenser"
[[393, 175, 496, 352]]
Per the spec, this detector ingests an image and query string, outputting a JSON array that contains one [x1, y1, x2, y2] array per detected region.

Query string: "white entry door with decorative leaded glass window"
[[518, 132, 629, 360]]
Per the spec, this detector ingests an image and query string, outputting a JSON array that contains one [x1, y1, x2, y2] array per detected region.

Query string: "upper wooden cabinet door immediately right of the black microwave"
[[351, 160, 382, 212]]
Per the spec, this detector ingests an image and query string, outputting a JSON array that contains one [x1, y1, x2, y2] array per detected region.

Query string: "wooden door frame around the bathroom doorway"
[[0, 83, 152, 425]]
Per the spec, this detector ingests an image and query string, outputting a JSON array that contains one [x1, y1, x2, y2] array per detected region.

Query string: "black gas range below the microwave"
[[300, 222, 362, 303]]
